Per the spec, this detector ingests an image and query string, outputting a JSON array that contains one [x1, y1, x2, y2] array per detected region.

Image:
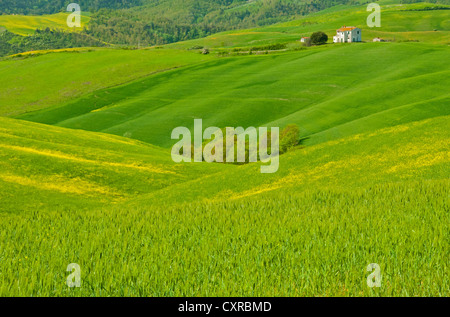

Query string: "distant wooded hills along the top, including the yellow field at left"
[[0, 0, 448, 56]]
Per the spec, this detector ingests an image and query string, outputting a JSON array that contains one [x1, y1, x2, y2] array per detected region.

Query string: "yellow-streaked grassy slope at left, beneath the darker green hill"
[[0, 118, 230, 214]]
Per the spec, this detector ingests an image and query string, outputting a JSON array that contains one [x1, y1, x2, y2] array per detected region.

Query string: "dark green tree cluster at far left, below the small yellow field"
[[0, 28, 104, 56]]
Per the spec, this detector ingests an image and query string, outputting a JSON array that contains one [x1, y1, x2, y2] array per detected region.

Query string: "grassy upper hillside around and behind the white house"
[[170, 0, 450, 48]]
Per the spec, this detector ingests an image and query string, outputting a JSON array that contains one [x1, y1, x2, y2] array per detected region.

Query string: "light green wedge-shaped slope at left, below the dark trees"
[[0, 49, 211, 116]]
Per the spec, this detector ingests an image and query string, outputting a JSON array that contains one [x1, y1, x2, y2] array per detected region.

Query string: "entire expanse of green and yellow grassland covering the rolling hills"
[[0, 0, 450, 297]]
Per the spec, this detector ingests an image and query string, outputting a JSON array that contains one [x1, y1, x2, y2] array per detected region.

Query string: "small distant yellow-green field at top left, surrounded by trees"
[[0, 12, 90, 35]]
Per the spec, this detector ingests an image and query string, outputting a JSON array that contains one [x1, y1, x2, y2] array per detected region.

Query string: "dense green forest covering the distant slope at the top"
[[86, 0, 362, 46]]
